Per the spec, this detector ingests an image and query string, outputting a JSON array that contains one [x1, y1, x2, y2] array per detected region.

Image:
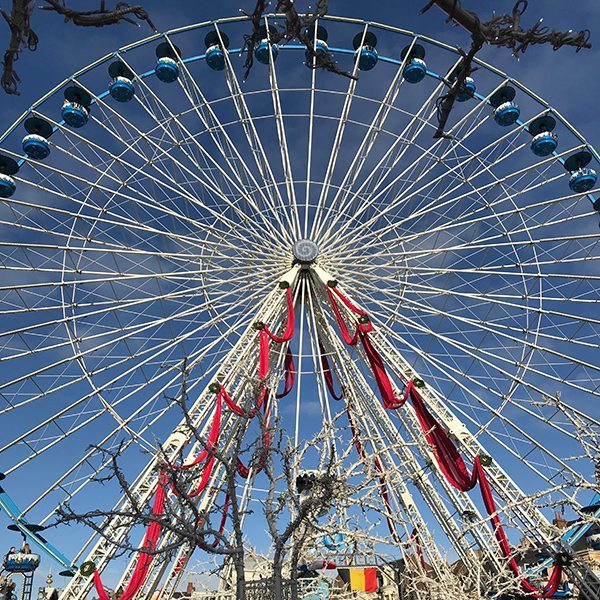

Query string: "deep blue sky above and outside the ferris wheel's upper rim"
[[0, 0, 600, 592]]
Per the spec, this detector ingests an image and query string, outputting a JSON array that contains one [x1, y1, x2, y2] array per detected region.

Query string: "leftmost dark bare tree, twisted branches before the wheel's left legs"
[[53, 360, 263, 600]]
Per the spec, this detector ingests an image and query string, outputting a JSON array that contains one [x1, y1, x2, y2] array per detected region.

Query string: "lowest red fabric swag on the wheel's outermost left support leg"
[[94, 473, 167, 600]]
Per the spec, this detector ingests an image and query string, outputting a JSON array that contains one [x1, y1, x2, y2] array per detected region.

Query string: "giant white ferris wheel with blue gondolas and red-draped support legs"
[[0, 11, 600, 599]]
